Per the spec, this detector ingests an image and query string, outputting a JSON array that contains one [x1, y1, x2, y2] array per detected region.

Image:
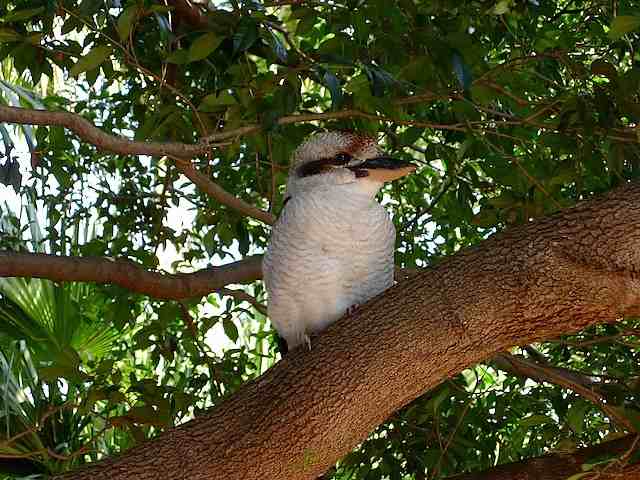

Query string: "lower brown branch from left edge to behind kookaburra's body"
[[0, 251, 262, 300]]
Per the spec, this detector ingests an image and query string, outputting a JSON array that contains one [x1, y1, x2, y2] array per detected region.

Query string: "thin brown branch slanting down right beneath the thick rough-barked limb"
[[493, 352, 636, 432]]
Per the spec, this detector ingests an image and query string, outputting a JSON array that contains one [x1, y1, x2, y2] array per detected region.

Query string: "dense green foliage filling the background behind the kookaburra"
[[0, 0, 640, 479]]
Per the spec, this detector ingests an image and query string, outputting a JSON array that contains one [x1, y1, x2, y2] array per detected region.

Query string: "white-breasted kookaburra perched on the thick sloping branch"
[[263, 132, 415, 349]]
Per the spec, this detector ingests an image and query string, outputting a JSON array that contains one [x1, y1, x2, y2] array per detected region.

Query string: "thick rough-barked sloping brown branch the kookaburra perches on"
[[42, 185, 640, 480]]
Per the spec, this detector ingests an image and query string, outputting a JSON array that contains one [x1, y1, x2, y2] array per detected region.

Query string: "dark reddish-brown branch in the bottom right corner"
[[447, 435, 640, 480]]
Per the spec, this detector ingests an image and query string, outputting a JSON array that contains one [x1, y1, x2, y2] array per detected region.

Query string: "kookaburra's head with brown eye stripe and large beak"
[[287, 131, 416, 196]]
